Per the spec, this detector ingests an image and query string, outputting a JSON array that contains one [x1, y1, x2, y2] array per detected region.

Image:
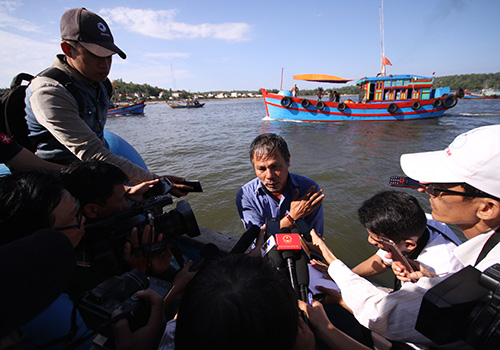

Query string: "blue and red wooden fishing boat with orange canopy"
[[262, 74, 460, 122]]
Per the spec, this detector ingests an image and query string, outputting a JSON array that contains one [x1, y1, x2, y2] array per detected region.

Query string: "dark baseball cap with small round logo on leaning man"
[[61, 7, 127, 59]]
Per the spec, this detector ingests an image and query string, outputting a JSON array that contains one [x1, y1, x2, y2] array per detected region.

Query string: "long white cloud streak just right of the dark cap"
[[99, 7, 250, 42]]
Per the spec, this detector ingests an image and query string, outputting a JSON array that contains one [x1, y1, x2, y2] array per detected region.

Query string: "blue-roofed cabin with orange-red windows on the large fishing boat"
[[356, 74, 434, 102]]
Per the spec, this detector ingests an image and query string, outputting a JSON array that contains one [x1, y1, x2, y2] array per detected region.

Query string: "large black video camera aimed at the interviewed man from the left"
[[81, 194, 200, 278]]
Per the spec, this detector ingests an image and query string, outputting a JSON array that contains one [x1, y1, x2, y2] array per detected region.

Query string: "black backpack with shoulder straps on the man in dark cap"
[[0, 67, 113, 152]]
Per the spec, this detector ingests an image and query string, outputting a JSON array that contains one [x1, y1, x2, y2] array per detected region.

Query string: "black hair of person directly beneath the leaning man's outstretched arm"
[[61, 160, 128, 206]]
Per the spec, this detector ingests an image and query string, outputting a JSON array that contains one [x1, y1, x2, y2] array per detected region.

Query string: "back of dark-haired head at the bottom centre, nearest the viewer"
[[175, 254, 298, 350]]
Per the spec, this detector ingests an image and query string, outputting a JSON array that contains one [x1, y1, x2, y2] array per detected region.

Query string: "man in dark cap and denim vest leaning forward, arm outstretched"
[[26, 8, 184, 189]]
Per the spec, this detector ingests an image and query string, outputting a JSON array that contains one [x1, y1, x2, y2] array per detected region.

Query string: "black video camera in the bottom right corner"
[[415, 264, 500, 349]]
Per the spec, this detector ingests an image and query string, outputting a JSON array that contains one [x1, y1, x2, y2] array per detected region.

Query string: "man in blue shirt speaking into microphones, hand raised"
[[236, 134, 325, 235]]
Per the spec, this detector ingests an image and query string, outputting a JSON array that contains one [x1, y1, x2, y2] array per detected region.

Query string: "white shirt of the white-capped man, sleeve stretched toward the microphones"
[[328, 231, 500, 346]]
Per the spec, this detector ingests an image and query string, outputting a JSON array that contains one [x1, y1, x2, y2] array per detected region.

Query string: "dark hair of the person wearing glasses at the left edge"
[[0, 171, 64, 244]]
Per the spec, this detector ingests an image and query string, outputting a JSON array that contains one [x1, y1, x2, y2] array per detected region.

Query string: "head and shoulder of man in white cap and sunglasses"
[[401, 125, 500, 271]]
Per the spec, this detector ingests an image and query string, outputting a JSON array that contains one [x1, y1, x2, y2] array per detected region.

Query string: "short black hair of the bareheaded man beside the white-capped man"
[[358, 191, 427, 243]]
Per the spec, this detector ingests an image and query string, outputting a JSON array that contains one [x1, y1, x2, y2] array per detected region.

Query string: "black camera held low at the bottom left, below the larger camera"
[[78, 270, 172, 338]]
